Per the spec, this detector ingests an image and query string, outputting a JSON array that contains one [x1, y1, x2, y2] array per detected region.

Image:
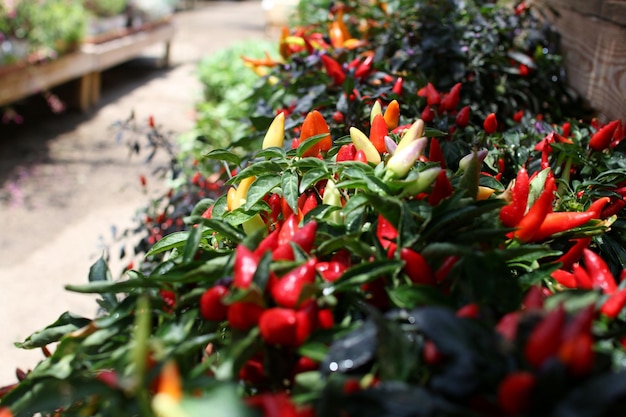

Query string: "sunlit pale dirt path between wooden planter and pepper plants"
[[0, 1, 266, 386]]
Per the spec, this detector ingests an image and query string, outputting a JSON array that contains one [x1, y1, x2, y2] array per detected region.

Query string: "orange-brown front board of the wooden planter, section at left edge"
[[0, 52, 94, 106]]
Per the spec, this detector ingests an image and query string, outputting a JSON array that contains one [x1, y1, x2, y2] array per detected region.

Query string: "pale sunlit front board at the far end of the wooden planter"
[[81, 24, 174, 70]]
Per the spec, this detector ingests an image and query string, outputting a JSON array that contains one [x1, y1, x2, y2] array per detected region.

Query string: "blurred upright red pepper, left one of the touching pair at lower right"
[[524, 305, 565, 368]]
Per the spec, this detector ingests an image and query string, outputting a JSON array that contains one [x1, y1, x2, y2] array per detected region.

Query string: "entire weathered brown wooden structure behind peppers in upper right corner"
[[533, 0, 626, 121]]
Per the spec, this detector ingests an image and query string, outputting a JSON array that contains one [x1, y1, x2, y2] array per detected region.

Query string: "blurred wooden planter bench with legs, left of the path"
[[0, 22, 174, 111]]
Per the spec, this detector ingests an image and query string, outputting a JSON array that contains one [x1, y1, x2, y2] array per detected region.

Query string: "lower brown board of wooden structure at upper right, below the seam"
[[528, 0, 626, 121]]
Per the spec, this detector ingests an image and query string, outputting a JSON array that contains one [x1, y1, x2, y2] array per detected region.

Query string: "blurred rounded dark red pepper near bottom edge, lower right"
[[498, 371, 536, 416]]
